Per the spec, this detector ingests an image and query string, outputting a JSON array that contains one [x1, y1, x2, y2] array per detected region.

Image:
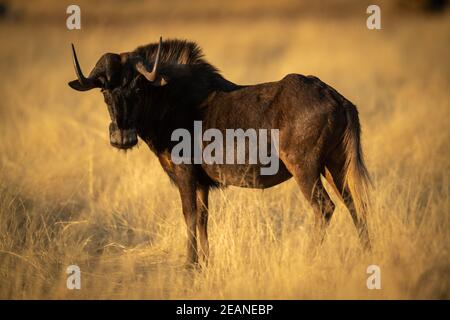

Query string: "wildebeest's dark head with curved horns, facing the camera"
[[69, 38, 167, 149]]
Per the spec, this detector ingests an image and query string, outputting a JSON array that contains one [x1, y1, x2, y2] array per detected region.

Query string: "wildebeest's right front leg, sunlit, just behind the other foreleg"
[[197, 186, 209, 266]]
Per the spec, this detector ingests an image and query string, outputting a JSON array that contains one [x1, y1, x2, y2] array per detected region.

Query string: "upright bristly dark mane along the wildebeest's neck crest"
[[135, 39, 218, 73]]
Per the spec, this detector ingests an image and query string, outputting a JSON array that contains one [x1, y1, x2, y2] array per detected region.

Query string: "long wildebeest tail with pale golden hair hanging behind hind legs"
[[343, 103, 371, 219]]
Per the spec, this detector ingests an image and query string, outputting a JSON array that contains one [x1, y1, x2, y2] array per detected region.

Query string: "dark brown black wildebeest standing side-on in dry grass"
[[69, 39, 370, 264]]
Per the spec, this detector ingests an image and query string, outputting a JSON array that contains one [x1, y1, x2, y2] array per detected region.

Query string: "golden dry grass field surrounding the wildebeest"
[[0, 0, 450, 299]]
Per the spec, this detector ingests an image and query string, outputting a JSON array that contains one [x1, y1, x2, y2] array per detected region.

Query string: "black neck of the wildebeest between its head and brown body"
[[136, 64, 239, 152]]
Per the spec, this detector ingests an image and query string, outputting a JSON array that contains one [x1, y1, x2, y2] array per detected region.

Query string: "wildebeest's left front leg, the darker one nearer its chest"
[[178, 172, 198, 266]]
